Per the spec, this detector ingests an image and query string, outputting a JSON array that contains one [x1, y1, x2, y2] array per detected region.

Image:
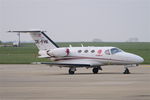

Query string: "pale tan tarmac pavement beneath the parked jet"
[[0, 64, 150, 100]]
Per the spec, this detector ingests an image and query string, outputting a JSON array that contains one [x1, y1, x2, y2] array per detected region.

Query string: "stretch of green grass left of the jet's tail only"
[[0, 44, 49, 64]]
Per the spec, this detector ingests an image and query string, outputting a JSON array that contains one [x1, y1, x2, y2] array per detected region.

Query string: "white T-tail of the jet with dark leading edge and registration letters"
[[9, 31, 59, 51]]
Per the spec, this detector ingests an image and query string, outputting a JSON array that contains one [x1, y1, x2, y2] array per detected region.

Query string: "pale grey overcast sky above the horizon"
[[0, 0, 150, 42]]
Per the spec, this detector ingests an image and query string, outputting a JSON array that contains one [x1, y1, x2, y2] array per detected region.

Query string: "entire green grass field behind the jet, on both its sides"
[[0, 42, 150, 64]]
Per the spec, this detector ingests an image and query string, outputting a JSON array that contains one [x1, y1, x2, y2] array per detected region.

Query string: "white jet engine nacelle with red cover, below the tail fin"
[[47, 48, 70, 57]]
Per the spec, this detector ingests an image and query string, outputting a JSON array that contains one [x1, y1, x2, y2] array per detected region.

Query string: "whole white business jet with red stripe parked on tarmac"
[[9, 31, 144, 74]]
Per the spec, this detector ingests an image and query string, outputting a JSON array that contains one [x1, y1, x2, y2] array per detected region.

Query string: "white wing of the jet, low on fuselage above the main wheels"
[[36, 60, 102, 67]]
